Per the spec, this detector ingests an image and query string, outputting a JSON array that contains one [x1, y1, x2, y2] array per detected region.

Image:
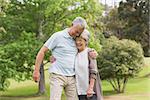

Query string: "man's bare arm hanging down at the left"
[[33, 46, 48, 82]]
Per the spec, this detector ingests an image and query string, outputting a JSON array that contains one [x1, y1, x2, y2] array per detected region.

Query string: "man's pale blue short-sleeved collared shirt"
[[44, 29, 77, 76]]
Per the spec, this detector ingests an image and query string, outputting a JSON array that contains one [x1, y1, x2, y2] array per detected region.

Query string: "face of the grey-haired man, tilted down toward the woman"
[[71, 25, 84, 37]]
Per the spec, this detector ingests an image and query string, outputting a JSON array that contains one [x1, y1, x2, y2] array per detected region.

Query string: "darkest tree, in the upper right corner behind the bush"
[[118, 0, 150, 56]]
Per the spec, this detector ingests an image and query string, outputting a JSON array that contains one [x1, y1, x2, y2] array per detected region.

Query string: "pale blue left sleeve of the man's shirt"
[[44, 33, 58, 50]]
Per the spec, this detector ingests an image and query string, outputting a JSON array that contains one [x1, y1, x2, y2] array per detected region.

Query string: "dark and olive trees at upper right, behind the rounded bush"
[[101, 0, 150, 56]]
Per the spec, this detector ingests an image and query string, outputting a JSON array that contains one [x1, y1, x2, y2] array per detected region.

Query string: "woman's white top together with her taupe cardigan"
[[75, 48, 103, 100]]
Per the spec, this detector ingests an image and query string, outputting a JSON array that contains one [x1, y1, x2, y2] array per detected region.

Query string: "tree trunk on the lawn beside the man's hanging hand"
[[38, 63, 45, 95]]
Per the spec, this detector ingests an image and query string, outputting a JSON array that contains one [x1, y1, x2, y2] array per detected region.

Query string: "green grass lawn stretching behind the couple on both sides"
[[0, 58, 150, 100]]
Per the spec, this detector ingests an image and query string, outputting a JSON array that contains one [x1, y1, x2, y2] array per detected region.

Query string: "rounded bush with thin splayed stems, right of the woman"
[[98, 37, 144, 92]]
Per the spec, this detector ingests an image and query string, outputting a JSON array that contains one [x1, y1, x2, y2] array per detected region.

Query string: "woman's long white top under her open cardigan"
[[75, 48, 89, 95]]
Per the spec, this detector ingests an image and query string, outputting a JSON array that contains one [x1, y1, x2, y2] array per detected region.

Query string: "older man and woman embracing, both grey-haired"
[[33, 17, 103, 100]]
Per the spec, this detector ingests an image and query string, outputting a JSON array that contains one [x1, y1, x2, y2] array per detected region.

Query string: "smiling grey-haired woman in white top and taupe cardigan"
[[75, 29, 103, 100]]
